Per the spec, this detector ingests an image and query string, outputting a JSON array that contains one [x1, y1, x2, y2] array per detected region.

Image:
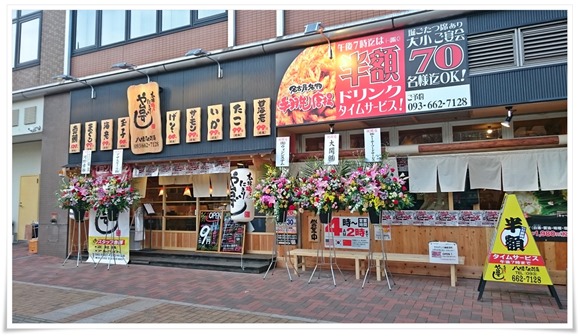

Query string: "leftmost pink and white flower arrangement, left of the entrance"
[[56, 176, 93, 211]]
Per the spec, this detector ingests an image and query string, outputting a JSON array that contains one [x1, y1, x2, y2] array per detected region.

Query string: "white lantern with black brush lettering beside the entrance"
[[230, 168, 254, 223]]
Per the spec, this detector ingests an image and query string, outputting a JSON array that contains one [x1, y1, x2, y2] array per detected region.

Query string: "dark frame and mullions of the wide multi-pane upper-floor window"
[[70, 9, 228, 56]]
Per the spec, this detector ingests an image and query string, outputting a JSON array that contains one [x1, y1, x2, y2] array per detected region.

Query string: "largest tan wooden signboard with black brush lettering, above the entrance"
[[127, 82, 163, 154]]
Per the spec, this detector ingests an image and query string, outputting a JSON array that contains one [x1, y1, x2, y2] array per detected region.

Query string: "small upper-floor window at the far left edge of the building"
[[12, 10, 42, 68]]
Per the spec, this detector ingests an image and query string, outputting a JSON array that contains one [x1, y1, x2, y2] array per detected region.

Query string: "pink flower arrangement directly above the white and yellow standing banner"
[[91, 175, 141, 213]]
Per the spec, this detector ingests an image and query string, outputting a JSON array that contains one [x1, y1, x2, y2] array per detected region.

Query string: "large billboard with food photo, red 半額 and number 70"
[[276, 18, 471, 126]]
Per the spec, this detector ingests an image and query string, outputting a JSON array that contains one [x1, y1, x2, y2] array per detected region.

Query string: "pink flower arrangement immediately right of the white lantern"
[[252, 165, 300, 217]]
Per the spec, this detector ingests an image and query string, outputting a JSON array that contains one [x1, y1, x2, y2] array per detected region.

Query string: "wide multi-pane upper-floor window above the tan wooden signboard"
[[73, 10, 227, 53]]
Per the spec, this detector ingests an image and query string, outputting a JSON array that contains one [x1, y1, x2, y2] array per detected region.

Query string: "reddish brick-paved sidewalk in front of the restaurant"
[[7, 242, 573, 330]]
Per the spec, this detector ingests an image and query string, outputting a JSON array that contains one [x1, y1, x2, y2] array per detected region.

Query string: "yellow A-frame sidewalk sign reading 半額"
[[477, 194, 562, 309]]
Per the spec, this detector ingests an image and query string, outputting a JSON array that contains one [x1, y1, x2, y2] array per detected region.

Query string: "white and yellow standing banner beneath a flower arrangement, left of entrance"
[[87, 209, 130, 265]]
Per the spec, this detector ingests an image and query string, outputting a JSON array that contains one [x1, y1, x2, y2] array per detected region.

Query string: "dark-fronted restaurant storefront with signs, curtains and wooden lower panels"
[[62, 12, 567, 283]]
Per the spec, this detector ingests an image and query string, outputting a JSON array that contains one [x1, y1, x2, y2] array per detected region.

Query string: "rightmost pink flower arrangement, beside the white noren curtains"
[[345, 163, 413, 213]]
